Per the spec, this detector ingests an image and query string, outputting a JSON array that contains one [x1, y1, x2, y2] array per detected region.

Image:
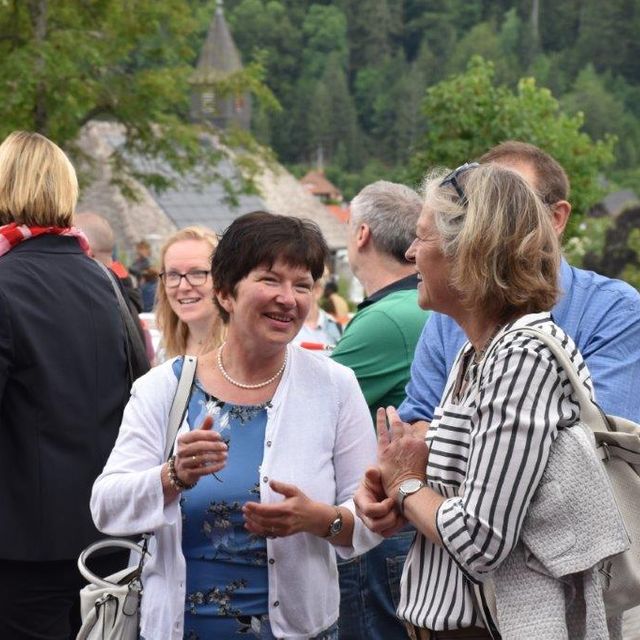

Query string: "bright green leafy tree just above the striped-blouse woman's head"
[[411, 57, 615, 235]]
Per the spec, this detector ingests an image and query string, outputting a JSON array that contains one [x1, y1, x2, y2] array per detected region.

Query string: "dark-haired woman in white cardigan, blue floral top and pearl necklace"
[[91, 211, 380, 640]]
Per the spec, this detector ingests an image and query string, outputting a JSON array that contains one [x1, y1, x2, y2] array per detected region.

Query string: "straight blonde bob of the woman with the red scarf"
[[0, 131, 78, 227]]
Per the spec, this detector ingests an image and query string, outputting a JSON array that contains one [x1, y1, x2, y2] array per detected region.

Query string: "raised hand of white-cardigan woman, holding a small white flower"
[[175, 416, 228, 484]]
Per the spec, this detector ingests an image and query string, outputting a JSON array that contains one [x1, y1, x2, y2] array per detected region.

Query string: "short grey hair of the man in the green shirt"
[[351, 180, 422, 263]]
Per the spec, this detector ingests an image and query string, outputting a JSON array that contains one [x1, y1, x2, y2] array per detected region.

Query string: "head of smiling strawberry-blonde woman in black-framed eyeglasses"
[[155, 226, 223, 363]]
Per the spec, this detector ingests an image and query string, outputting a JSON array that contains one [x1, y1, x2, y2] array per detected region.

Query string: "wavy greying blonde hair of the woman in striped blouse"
[[424, 164, 560, 320]]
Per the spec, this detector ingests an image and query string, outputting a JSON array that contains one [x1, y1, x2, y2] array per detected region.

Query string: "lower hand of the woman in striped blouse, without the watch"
[[353, 467, 407, 538]]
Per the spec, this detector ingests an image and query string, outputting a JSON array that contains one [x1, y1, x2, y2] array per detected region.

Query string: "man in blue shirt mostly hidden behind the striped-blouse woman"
[[399, 142, 640, 423]]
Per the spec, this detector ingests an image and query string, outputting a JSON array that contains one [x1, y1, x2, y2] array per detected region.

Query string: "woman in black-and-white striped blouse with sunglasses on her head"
[[355, 163, 615, 640]]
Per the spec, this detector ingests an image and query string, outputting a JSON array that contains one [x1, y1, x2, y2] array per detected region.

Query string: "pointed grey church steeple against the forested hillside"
[[191, 0, 251, 129]]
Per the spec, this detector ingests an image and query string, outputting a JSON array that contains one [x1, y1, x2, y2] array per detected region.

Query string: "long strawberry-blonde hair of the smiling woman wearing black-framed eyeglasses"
[[155, 226, 224, 358]]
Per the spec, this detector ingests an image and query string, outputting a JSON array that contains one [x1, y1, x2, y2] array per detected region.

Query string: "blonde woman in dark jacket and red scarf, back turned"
[[0, 132, 128, 640]]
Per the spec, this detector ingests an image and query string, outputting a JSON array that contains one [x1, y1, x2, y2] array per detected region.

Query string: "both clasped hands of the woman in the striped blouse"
[[354, 407, 429, 537]]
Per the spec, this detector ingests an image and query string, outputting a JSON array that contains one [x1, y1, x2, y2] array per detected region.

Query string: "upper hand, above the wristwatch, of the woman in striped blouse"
[[376, 407, 429, 500]]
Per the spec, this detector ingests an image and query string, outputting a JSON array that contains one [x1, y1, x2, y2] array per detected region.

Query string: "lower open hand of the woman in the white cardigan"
[[242, 480, 328, 537]]
